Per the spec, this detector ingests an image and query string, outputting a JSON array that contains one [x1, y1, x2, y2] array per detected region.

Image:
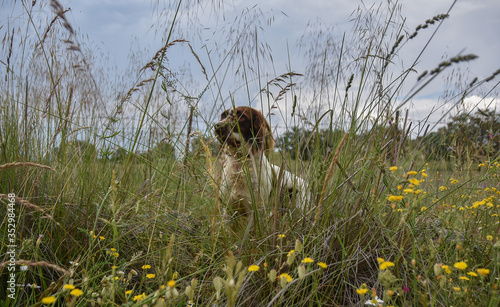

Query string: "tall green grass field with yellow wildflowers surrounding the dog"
[[0, 1, 500, 306]]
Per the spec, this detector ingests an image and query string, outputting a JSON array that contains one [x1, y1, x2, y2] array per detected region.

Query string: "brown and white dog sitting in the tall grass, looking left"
[[214, 107, 308, 226]]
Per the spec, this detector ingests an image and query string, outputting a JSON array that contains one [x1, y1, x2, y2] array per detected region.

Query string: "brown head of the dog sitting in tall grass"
[[214, 107, 274, 153]]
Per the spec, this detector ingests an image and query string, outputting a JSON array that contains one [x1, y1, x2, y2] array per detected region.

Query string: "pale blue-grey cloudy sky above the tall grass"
[[0, 0, 500, 137]]
